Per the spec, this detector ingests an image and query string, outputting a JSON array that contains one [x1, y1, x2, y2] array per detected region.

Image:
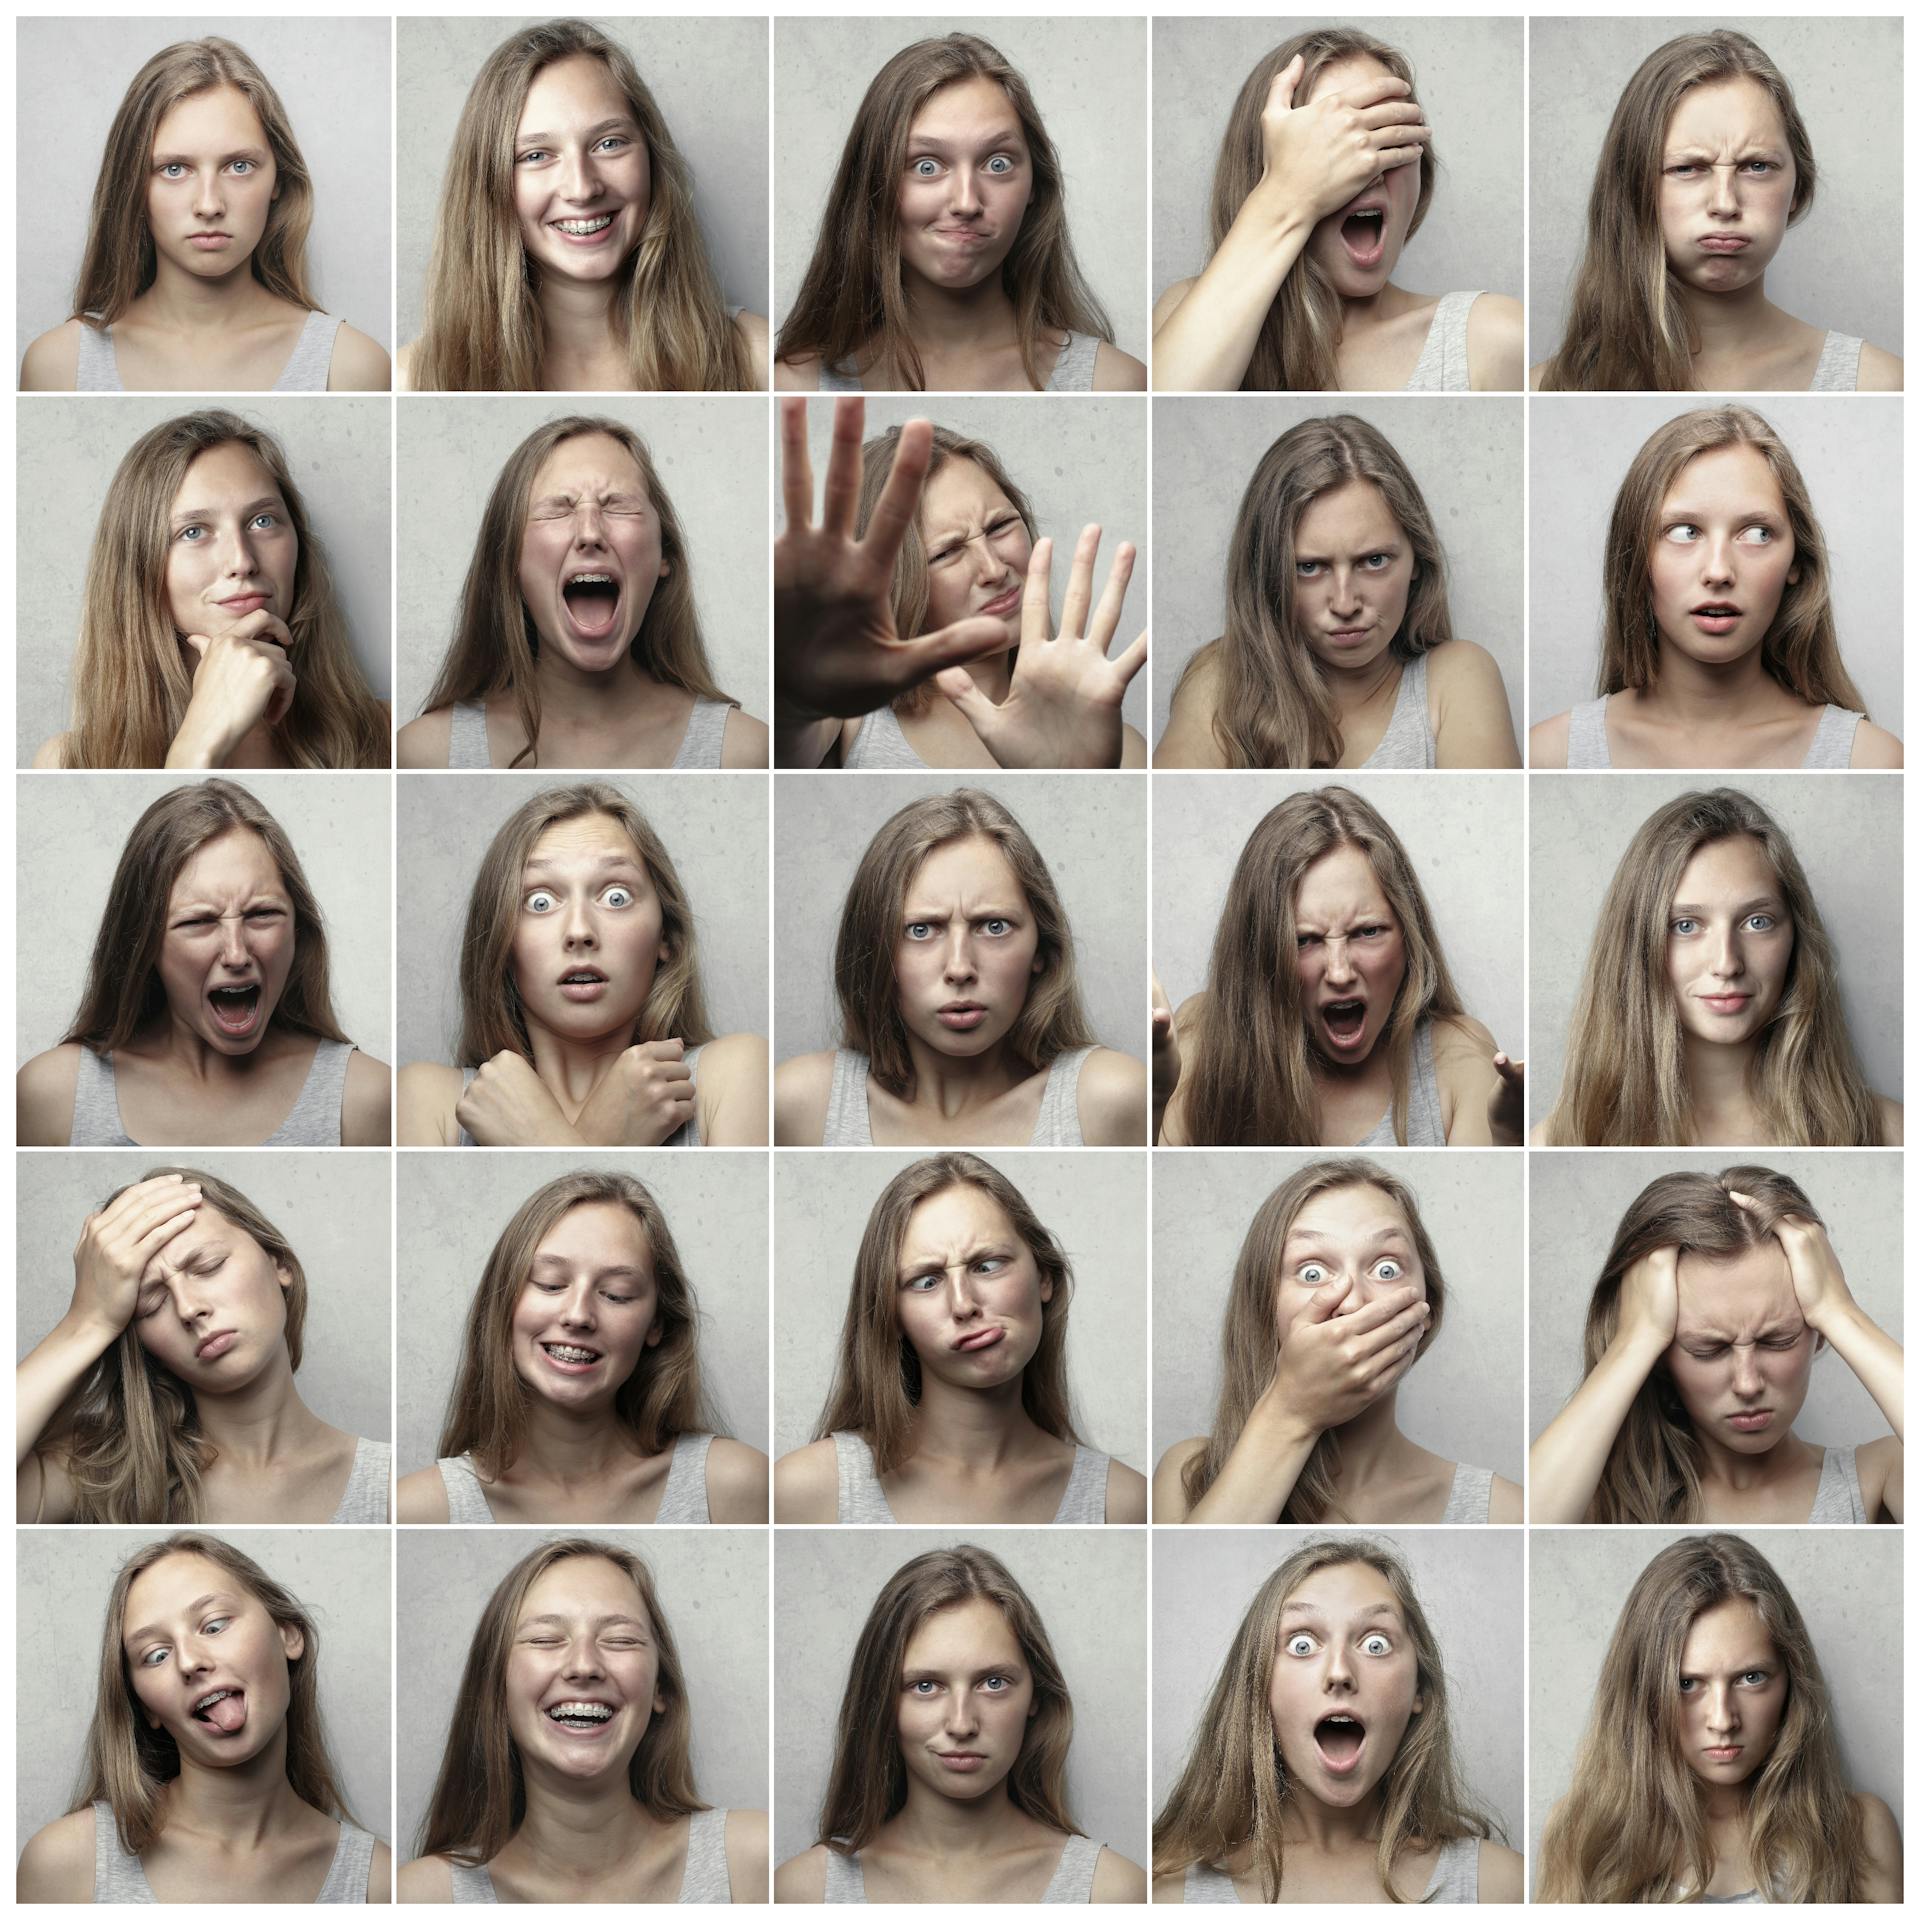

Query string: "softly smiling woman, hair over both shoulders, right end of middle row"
[[1534, 787, 1905, 1146]]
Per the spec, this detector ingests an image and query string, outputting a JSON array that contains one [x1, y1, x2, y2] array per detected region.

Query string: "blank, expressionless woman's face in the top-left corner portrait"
[[146, 86, 280, 280]]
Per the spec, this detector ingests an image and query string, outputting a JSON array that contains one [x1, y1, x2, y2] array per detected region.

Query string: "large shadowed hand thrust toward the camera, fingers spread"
[[774, 397, 1006, 730]]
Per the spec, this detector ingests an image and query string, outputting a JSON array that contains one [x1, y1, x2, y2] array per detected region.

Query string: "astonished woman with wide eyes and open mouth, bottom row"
[[1154, 1534, 1521, 1907]]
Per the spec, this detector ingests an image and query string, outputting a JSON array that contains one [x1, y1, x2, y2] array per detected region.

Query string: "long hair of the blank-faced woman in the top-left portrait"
[[69, 35, 321, 326]]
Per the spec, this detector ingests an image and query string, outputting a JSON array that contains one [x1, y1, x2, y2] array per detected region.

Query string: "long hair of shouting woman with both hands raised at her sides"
[[1181, 787, 1463, 1146]]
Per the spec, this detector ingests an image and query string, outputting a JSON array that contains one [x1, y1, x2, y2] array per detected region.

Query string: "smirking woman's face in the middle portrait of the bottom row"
[[899, 1596, 1037, 1801]]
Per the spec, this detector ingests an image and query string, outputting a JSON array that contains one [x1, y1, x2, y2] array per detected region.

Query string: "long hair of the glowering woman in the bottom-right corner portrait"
[[1534, 1534, 1866, 1905]]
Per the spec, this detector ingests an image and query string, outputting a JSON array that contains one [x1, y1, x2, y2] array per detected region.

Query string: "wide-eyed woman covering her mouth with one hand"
[[1154, 1160, 1521, 1526]]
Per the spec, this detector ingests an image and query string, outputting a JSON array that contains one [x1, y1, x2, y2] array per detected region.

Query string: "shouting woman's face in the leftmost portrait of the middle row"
[[159, 828, 294, 1060]]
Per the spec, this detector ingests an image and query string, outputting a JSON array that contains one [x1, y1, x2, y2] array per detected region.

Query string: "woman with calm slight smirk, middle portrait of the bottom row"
[[774, 1546, 1146, 1905]]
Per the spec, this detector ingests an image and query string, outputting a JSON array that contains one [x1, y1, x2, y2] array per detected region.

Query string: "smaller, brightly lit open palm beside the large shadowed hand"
[[933, 526, 1146, 766]]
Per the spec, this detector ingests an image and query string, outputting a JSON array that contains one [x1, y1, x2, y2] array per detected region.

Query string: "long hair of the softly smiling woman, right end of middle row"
[[1546, 787, 1882, 1146]]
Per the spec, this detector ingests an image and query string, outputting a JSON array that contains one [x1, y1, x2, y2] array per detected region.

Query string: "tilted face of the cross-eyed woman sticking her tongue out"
[[121, 1553, 307, 1766]]
